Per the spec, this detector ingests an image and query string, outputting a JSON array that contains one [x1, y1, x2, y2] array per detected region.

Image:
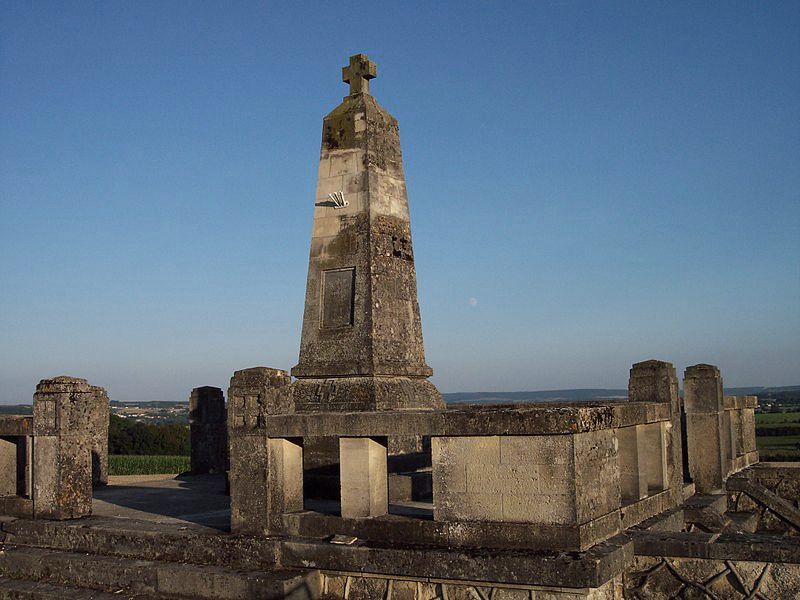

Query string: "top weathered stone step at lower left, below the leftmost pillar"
[[0, 517, 277, 571]]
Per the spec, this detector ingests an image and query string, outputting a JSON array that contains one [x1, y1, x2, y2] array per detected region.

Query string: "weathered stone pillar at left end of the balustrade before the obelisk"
[[228, 367, 294, 535]]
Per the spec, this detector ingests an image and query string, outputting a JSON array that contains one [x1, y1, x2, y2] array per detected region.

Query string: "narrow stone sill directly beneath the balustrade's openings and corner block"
[[281, 511, 620, 551]]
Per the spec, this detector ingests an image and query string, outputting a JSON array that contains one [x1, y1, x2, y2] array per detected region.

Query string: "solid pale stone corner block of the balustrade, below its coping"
[[432, 430, 620, 525]]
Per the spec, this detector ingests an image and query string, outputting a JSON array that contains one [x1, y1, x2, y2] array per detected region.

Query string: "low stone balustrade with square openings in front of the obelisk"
[[247, 402, 680, 550]]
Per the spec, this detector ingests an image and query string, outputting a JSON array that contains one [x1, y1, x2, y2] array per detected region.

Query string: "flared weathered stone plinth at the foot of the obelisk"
[[292, 376, 445, 412]]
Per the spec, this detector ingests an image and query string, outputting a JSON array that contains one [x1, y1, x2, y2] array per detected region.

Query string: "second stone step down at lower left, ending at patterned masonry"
[[0, 543, 319, 600]]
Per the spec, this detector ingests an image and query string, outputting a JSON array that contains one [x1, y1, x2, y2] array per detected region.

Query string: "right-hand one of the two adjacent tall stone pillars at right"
[[683, 364, 728, 494]]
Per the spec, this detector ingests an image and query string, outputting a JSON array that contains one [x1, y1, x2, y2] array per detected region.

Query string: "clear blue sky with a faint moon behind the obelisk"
[[0, 0, 800, 402]]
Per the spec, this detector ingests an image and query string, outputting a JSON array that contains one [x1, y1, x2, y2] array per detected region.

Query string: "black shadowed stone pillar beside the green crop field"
[[189, 386, 228, 475]]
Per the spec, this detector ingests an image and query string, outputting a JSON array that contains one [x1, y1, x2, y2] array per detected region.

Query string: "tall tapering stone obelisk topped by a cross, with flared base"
[[292, 54, 442, 410]]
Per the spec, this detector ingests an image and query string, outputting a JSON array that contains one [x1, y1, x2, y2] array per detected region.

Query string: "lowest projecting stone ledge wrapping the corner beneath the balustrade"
[[281, 536, 633, 588]]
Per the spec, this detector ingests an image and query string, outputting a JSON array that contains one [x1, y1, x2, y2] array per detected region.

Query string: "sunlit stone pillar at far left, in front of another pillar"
[[33, 377, 97, 519]]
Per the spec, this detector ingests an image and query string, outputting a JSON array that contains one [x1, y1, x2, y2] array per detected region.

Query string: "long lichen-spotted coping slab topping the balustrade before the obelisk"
[[262, 402, 669, 437]]
